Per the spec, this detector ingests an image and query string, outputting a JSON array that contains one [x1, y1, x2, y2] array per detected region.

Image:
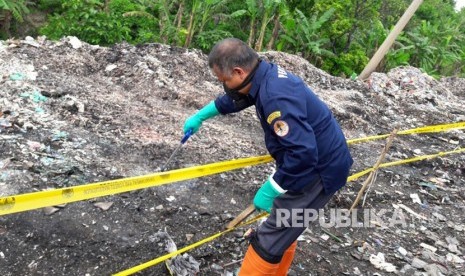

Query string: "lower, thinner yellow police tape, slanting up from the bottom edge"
[[113, 148, 465, 276]]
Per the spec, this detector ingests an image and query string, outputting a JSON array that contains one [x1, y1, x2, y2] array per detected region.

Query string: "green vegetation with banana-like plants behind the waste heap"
[[0, 0, 465, 77]]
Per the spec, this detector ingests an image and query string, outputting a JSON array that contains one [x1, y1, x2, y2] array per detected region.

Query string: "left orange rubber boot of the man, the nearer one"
[[238, 245, 279, 276]]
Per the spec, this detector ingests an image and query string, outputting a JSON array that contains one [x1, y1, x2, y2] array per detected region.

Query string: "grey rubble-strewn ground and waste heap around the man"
[[0, 37, 465, 276]]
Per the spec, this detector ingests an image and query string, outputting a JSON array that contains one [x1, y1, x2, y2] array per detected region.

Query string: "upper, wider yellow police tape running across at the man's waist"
[[0, 122, 465, 216]]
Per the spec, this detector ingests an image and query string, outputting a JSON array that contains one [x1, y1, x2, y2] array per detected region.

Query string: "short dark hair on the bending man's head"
[[208, 38, 258, 75]]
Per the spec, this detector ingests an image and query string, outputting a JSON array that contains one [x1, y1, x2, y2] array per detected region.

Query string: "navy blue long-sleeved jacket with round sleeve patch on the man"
[[215, 61, 353, 193]]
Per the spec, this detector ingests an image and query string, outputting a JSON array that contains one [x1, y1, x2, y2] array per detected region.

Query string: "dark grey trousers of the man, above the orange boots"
[[251, 180, 334, 263]]
